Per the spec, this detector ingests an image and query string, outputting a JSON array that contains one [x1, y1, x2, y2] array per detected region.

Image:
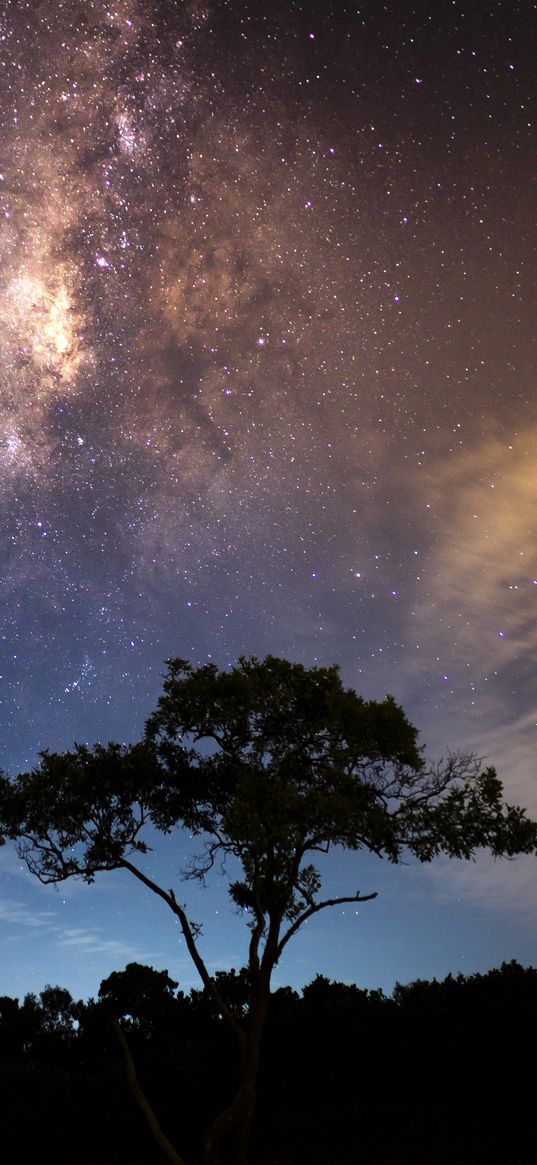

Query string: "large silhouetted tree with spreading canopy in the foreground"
[[0, 656, 537, 1165]]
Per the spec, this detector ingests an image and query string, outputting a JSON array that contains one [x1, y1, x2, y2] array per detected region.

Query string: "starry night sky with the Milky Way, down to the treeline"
[[0, 0, 537, 997]]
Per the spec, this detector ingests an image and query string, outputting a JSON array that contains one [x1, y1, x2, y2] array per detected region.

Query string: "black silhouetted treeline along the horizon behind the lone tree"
[[0, 962, 537, 1165]]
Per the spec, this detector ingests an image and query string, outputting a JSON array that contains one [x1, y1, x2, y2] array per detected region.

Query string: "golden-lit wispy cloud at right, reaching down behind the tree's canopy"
[[393, 428, 537, 920]]
